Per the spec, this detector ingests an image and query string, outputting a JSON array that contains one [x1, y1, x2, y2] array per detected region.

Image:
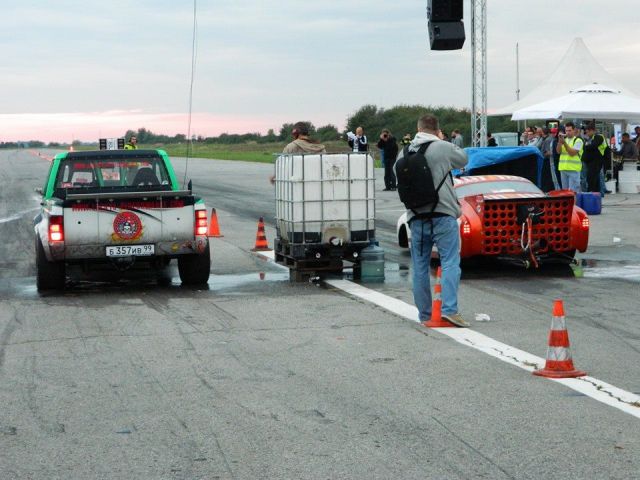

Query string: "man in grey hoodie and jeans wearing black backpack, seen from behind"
[[395, 114, 469, 327]]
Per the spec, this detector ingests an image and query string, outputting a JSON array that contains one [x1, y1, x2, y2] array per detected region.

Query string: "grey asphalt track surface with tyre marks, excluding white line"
[[0, 151, 640, 479]]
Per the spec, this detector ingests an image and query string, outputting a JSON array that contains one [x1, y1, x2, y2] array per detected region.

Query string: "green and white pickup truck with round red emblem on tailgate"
[[34, 150, 210, 290]]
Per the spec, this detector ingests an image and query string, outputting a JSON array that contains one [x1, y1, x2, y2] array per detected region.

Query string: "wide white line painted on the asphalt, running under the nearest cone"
[[325, 280, 640, 418]]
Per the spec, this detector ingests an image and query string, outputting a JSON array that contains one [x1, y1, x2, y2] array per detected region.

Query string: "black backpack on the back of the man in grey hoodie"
[[396, 142, 448, 213]]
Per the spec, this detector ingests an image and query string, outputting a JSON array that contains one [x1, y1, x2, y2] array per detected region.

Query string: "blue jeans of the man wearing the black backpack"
[[410, 216, 460, 322]]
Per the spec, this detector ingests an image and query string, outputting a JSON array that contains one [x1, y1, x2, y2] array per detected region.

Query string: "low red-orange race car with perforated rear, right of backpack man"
[[397, 175, 589, 267]]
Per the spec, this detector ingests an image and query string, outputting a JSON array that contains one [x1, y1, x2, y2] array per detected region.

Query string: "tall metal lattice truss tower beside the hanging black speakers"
[[470, 0, 487, 147]]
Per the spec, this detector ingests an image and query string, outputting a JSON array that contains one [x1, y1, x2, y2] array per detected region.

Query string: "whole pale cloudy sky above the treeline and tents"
[[0, 0, 640, 141]]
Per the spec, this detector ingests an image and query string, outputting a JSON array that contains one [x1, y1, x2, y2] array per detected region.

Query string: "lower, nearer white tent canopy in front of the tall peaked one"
[[511, 83, 640, 122]]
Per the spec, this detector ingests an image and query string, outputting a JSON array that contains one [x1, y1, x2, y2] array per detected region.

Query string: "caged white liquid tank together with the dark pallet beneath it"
[[275, 152, 375, 280]]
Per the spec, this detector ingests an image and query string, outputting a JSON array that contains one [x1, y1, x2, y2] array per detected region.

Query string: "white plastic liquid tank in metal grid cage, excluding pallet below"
[[276, 153, 375, 245]]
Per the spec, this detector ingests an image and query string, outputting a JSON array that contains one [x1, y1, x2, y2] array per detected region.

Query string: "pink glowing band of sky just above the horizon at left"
[[0, 111, 283, 143]]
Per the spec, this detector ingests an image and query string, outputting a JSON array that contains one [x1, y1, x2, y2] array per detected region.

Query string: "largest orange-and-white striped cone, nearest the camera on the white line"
[[533, 300, 587, 378]]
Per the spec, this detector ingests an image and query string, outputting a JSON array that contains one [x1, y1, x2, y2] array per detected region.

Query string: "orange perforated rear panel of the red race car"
[[482, 197, 574, 255]]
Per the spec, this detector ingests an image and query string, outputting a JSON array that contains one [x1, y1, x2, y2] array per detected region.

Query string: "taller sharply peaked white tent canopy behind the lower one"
[[488, 38, 636, 118]]
